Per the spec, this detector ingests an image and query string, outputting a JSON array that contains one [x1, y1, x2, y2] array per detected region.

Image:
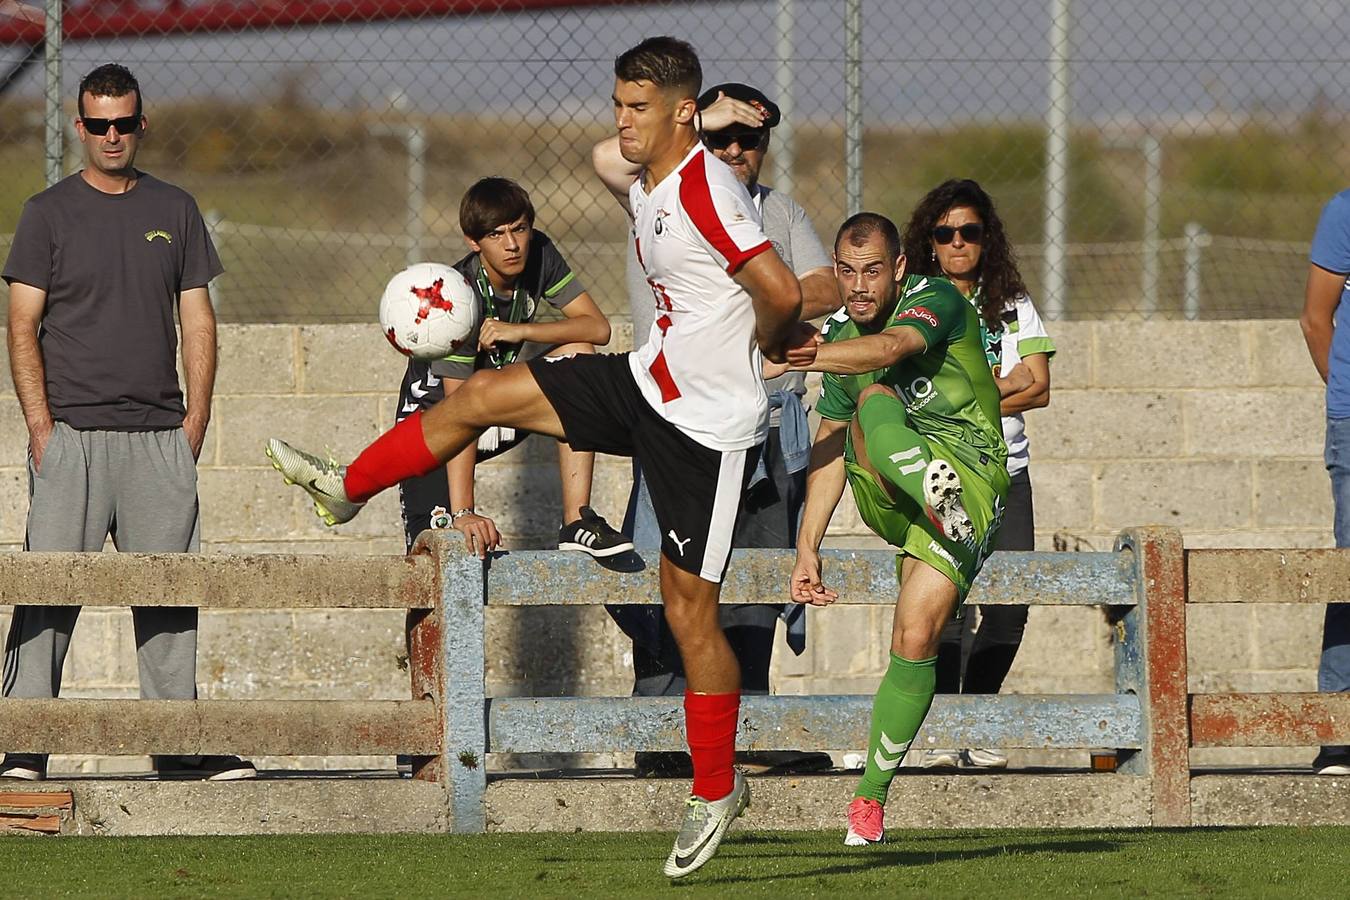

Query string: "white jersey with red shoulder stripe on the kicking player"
[[628, 144, 772, 451]]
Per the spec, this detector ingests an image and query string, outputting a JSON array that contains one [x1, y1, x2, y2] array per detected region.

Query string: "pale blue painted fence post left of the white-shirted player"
[[436, 537, 487, 834]]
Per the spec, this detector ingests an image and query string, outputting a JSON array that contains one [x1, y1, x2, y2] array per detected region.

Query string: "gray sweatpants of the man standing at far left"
[[4, 422, 201, 712]]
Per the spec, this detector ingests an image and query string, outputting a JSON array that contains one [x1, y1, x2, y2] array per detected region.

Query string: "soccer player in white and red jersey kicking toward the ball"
[[267, 38, 817, 878]]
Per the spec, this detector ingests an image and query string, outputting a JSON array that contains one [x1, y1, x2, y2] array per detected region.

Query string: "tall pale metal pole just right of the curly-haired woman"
[[1044, 0, 1071, 318]]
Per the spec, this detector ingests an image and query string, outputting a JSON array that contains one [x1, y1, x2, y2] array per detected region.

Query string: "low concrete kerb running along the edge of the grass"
[[0, 770, 1350, 835]]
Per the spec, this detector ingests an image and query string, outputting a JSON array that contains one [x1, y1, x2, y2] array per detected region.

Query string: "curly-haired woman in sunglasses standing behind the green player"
[[905, 178, 1054, 769]]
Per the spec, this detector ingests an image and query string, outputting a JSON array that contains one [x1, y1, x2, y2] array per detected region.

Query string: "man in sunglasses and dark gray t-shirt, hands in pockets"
[[0, 63, 255, 780]]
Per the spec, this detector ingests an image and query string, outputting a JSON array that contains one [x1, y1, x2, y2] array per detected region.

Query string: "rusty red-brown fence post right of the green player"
[[1115, 526, 1191, 826]]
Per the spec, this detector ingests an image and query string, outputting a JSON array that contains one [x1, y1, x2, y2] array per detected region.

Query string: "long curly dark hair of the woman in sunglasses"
[[905, 178, 1026, 331]]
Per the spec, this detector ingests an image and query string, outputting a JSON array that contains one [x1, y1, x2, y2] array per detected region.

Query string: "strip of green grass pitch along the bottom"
[[0, 827, 1350, 900]]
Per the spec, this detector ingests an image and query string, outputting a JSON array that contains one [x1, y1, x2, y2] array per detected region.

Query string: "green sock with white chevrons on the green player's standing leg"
[[853, 653, 937, 803]]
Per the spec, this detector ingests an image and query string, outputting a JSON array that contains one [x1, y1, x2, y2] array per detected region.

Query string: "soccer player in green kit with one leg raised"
[[790, 213, 1008, 846]]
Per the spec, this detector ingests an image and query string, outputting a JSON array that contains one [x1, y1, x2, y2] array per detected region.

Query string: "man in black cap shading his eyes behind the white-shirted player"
[[595, 82, 840, 775]]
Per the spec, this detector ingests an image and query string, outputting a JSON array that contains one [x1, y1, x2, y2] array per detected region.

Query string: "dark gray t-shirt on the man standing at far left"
[[4, 173, 224, 430]]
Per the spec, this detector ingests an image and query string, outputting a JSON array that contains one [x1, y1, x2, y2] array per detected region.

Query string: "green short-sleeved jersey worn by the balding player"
[[815, 275, 1007, 470]]
